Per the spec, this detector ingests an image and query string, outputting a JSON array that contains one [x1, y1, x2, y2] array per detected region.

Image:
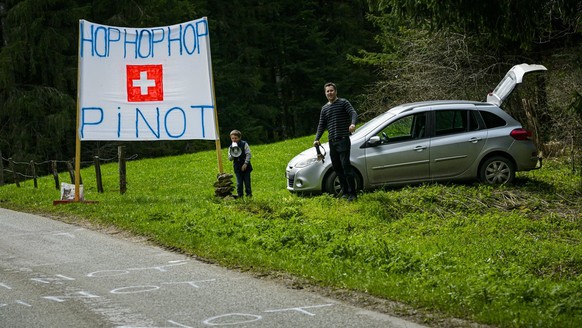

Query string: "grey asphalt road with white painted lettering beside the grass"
[[0, 208, 428, 328]]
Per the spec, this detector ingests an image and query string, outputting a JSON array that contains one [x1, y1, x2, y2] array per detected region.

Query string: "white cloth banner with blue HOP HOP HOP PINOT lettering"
[[78, 18, 216, 141]]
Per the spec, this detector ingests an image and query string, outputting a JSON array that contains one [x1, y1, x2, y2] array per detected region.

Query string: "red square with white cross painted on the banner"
[[126, 65, 164, 102]]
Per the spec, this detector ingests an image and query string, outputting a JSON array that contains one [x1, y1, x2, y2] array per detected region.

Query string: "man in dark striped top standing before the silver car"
[[313, 82, 358, 201]]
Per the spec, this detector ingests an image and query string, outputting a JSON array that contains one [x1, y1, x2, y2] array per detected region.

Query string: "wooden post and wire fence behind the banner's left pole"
[[0, 146, 138, 193]]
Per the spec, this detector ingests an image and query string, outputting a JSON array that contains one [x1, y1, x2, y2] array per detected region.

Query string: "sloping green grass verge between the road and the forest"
[[0, 137, 582, 327]]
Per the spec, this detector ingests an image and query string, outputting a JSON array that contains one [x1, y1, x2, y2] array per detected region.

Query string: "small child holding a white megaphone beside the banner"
[[228, 130, 253, 198]]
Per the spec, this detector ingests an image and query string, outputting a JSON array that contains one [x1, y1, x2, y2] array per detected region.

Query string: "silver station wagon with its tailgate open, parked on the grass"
[[286, 64, 546, 194]]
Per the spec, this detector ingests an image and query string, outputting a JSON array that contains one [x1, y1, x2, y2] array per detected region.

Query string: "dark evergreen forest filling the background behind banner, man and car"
[[0, 0, 582, 169]]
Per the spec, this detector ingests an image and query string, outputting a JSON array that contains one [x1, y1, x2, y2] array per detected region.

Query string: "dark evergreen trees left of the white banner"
[[0, 0, 82, 160]]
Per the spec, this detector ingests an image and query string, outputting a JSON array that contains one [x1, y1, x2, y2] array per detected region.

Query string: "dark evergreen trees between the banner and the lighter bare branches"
[[208, 0, 374, 143]]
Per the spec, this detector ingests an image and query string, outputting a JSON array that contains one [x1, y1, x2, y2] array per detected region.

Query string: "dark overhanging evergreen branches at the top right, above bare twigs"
[[374, 0, 582, 51]]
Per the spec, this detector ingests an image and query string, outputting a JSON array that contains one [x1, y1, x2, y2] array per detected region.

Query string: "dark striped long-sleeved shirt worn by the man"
[[315, 98, 358, 140]]
